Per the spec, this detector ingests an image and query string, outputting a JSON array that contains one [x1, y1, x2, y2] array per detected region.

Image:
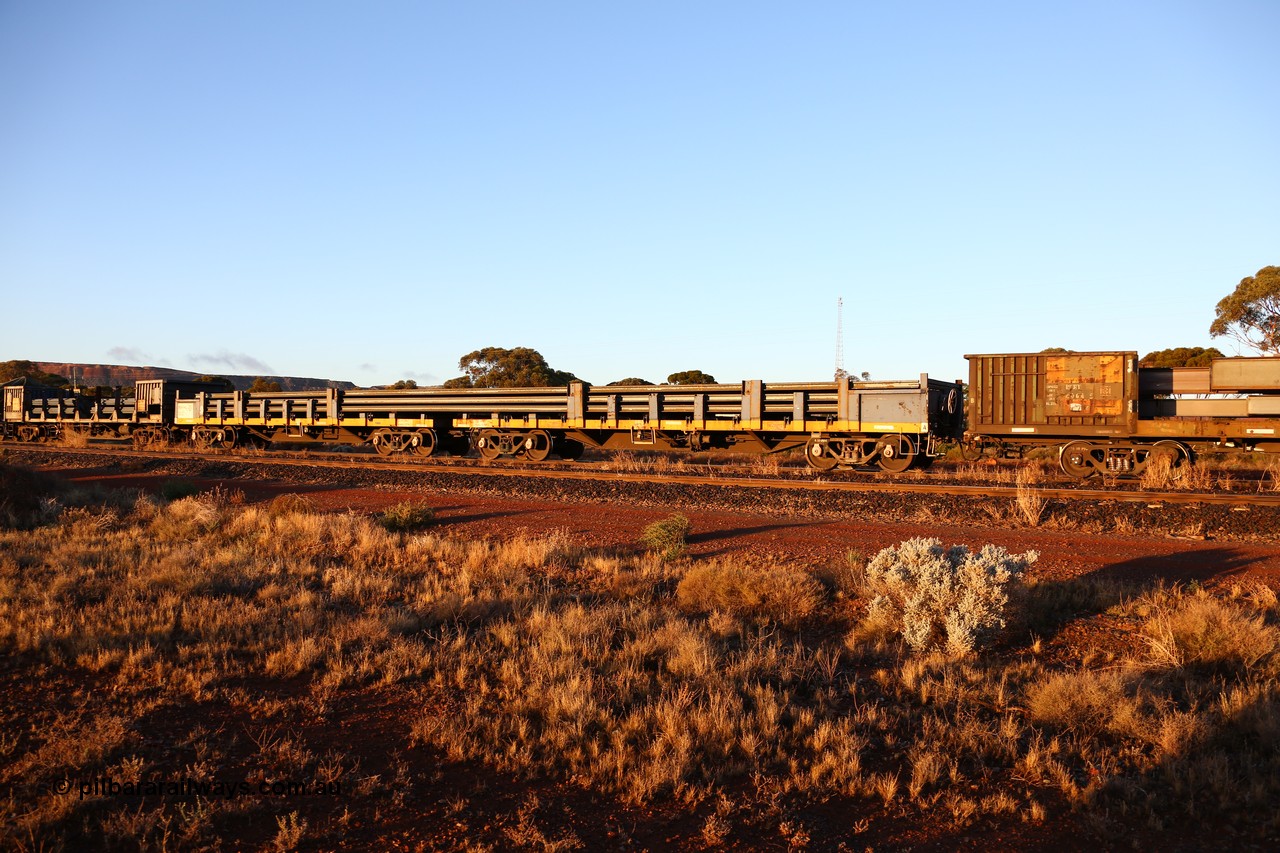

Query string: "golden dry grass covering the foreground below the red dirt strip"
[[0, 466, 1280, 849]]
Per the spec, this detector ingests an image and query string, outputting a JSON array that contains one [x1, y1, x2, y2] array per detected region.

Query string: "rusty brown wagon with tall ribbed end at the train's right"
[[964, 351, 1280, 479]]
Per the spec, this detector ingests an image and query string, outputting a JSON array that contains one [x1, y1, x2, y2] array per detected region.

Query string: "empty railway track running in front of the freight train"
[[10, 444, 1280, 507]]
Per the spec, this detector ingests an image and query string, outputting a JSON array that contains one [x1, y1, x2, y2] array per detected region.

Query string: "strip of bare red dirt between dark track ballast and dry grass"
[[46, 458, 1280, 589]]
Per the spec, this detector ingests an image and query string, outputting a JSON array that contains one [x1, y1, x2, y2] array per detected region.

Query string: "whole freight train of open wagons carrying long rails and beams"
[[0, 351, 1280, 478]]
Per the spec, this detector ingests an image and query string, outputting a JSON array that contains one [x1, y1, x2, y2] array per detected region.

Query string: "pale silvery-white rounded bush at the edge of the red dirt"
[[867, 538, 1039, 654]]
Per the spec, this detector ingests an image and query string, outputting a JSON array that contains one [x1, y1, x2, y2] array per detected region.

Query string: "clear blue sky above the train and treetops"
[[0, 0, 1280, 384]]
